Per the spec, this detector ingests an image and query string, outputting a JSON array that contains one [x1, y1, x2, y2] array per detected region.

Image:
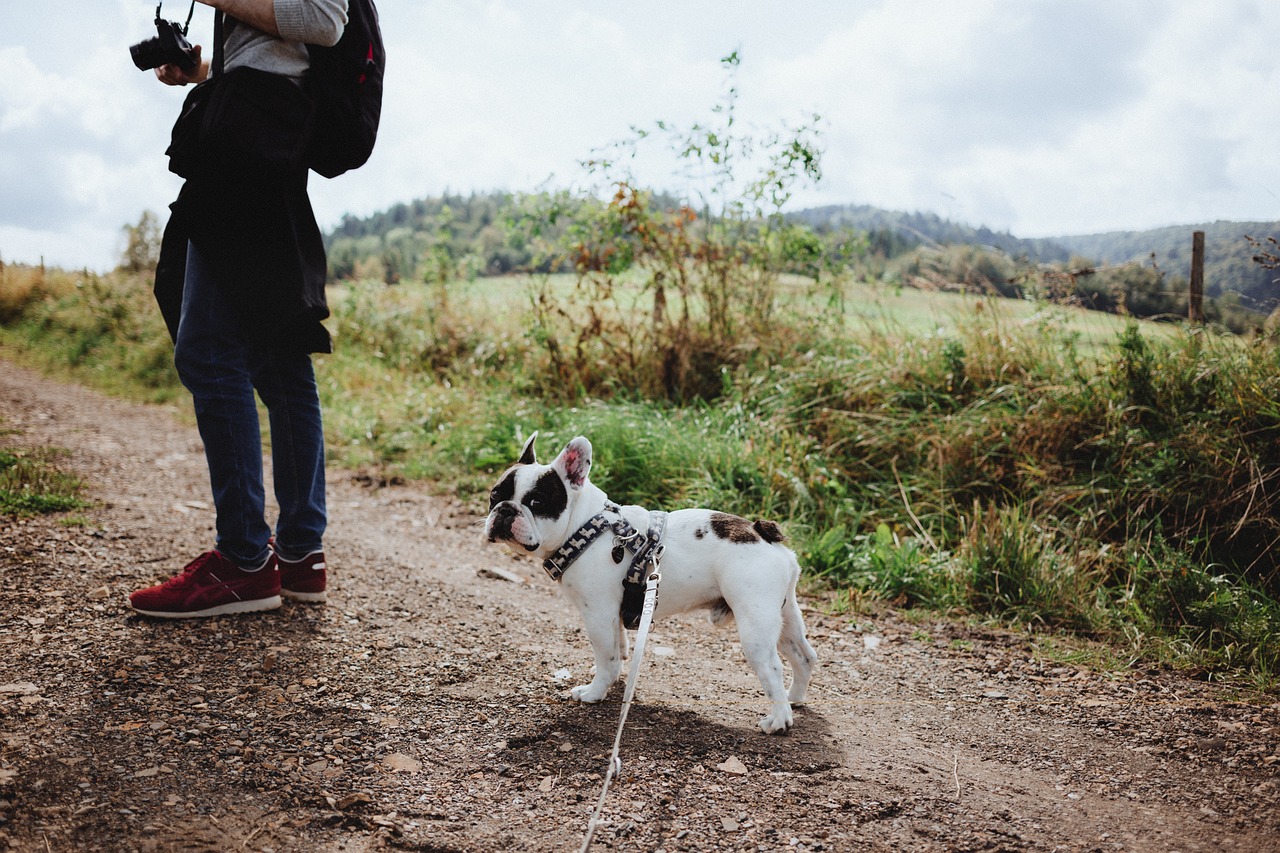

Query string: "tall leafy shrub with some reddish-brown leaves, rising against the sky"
[[509, 54, 829, 402]]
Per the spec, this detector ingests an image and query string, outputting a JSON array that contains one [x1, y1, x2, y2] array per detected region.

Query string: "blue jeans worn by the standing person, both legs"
[[174, 245, 326, 567]]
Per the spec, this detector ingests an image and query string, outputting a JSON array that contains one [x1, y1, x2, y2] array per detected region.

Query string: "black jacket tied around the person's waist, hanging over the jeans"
[[155, 60, 333, 352]]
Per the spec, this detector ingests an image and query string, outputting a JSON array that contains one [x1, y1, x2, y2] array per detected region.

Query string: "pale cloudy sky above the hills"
[[0, 0, 1280, 270]]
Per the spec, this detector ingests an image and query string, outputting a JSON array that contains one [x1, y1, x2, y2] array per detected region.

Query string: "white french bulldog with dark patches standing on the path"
[[484, 433, 818, 734]]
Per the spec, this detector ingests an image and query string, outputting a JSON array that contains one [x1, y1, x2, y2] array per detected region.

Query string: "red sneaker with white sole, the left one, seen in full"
[[129, 551, 280, 619]]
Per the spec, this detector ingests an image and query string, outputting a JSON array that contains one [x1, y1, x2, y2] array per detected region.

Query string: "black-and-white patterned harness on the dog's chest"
[[543, 503, 667, 629]]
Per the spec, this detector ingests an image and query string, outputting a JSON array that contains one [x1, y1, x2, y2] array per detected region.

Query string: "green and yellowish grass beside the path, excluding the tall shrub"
[[0, 262, 1280, 688]]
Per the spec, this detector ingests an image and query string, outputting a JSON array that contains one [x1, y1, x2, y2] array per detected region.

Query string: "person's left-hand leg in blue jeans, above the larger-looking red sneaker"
[[174, 245, 271, 569]]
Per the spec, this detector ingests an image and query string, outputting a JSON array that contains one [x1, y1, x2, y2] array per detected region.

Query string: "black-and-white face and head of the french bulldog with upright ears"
[[484, 433, 591, 552]]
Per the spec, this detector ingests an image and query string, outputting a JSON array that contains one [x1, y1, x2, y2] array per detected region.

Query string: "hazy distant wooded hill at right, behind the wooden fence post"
[[790, 205, 1280, 311]]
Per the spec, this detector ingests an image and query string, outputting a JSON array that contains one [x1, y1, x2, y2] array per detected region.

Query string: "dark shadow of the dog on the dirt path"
[[504, 699, 844, 774]]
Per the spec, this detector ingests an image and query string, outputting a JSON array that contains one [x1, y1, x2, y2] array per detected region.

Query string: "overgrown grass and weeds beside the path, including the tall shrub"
[[0, 54, 1280, 688]]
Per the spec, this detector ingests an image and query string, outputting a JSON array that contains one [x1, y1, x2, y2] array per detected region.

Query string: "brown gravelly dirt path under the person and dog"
[[0, 361, 1280, 852]]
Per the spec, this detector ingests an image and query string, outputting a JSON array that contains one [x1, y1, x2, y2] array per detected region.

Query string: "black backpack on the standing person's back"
[[307, 0, 387, 178]]
